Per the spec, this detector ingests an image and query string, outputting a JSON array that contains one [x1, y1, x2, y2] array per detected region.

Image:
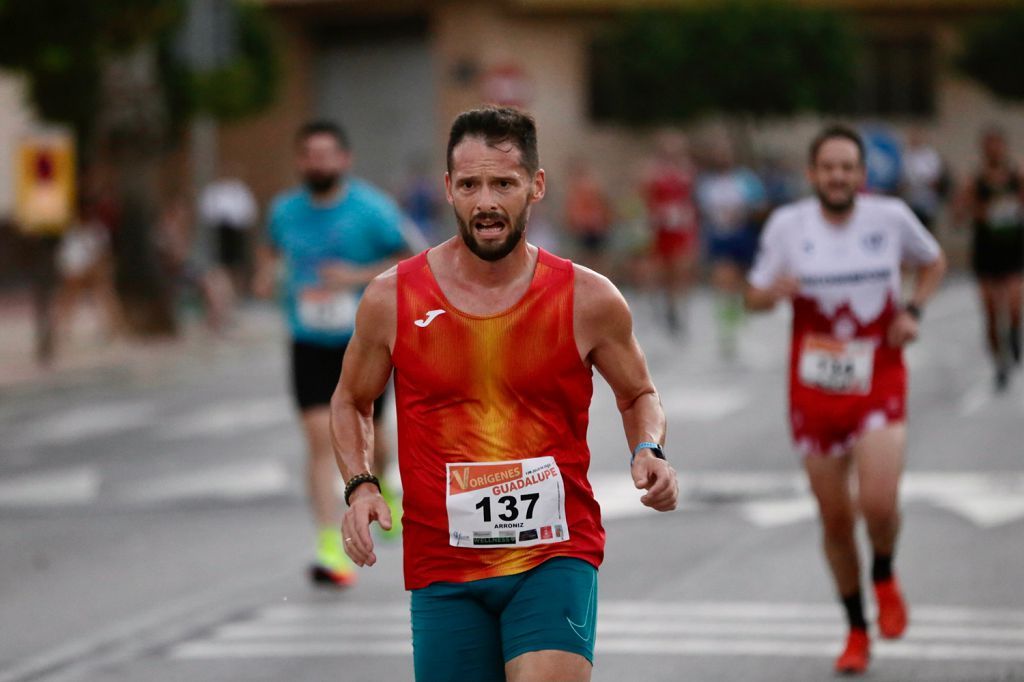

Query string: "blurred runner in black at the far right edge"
[[957, 128, 1024, 391]]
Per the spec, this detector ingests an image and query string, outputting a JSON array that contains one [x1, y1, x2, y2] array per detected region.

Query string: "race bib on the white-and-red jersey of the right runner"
[[797, 334, 874, 394]]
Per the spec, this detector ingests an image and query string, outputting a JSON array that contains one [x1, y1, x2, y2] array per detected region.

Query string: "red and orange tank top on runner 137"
[[392, 250, 604, 590]]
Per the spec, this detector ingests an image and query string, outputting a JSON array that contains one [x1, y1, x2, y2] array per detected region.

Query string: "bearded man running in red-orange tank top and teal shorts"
[[332, 108, 679, 680]]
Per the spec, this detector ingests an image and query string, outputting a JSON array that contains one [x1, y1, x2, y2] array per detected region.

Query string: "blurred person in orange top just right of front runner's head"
[[565, 159, 611, 275]]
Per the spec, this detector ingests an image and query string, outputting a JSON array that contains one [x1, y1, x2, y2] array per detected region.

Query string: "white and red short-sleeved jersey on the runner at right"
[[749, 195, 940, 400]]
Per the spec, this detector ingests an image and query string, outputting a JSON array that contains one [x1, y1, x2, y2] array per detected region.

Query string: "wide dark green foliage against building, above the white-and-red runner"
[[592, 0, 857, 124]]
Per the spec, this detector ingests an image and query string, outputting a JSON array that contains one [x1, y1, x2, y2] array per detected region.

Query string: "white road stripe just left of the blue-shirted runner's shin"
[[122, 460, 290, 503]]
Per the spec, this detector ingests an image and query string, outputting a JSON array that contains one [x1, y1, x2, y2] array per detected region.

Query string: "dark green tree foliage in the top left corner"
[[0, 0, 279, 146]]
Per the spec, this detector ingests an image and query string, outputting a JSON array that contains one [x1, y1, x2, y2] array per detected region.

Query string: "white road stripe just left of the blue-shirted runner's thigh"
[[158, 398, 295, 440]]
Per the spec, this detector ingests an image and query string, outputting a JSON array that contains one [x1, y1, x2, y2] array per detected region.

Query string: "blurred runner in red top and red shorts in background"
[[641, 130, 699, 334]]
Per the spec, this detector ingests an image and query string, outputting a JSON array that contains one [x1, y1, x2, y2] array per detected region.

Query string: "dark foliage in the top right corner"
[[957, 3, 1024, 100]]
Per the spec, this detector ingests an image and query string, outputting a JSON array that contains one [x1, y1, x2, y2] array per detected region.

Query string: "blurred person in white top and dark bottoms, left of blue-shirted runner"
[[199, 166, 259, 296]]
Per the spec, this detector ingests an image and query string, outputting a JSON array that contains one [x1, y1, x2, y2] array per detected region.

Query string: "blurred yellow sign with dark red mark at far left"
[[14, 131, 75, 236]]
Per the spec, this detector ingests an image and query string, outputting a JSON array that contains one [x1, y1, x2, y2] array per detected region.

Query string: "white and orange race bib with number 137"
[[445, 457, 569, 549]]
